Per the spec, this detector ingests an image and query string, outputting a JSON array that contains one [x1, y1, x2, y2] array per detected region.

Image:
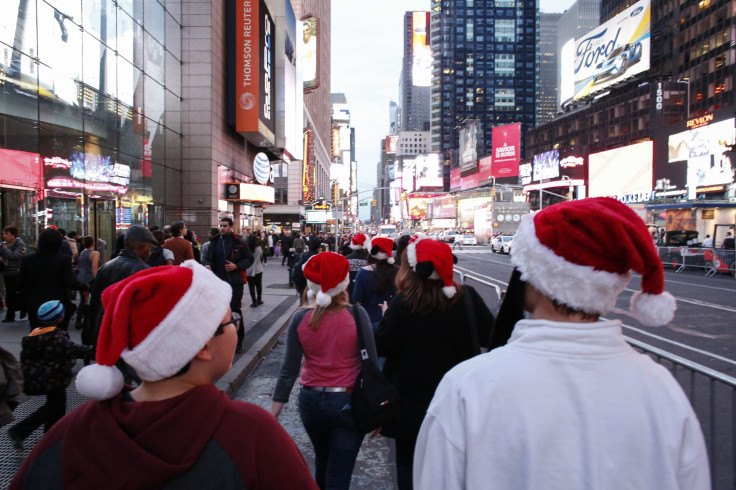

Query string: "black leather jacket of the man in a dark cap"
[[87, 249, 150, 345]]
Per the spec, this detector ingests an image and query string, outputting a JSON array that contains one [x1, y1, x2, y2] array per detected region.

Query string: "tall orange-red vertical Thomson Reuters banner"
[[235, 0, 261, 132]]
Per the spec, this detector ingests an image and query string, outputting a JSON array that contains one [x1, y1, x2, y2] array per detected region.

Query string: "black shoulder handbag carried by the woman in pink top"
[[352, 306, 399, 433]]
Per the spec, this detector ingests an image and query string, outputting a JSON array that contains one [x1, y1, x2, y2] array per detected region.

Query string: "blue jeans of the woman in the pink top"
[[299, 389, 365, 490]]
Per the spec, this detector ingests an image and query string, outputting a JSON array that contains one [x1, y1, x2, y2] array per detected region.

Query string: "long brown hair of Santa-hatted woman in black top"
[[396, 251, 463, 315]]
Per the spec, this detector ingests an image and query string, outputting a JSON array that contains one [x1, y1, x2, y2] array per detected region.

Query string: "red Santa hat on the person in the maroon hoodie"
[[76, 260, 232, 400]]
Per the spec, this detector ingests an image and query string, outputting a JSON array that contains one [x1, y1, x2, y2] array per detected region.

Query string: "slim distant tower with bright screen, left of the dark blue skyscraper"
[[400, 12, 432, 131]]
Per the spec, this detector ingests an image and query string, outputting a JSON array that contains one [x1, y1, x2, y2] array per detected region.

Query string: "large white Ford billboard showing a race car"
[[573, 0, 652, 99]]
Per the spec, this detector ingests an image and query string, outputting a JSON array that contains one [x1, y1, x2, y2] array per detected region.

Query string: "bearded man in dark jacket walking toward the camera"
[[207, 217, 253, 353]]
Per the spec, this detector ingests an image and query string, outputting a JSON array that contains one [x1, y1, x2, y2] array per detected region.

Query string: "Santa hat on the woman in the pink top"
[[303, 252, 350, 306]]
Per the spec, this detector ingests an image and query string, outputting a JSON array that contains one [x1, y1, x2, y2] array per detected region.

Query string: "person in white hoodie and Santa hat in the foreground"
[[414, 198, 711, 490]]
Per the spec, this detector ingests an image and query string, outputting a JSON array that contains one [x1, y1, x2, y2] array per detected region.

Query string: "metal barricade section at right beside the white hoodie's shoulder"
[[626, 337, 736, 489]]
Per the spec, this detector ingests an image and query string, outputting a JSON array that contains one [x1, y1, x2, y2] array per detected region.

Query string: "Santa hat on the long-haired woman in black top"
[[406, 235, 457, 298]]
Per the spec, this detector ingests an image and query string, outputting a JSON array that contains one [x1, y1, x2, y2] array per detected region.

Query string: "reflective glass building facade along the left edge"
[[0, 0, 182, 249]]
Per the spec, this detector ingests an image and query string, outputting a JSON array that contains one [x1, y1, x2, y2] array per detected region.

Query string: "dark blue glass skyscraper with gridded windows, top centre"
[[430, 0, 539, 161]]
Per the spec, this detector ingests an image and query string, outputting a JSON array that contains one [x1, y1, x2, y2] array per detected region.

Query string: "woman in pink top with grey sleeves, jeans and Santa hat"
[[271, 252, 377, 489]]
